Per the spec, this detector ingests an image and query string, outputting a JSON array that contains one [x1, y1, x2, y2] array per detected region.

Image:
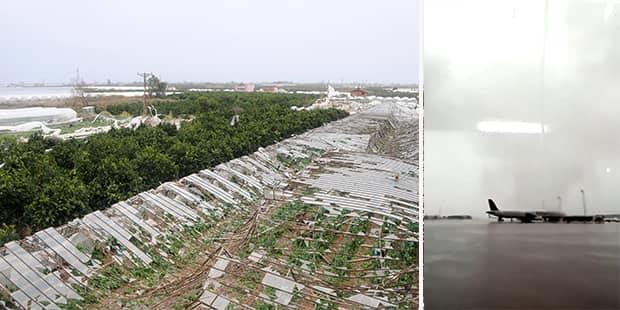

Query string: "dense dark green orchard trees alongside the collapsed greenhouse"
[[0, 93, 347, 234]]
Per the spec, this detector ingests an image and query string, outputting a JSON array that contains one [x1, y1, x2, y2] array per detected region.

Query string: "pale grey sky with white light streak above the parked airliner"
[[424, 0, 620, 215]]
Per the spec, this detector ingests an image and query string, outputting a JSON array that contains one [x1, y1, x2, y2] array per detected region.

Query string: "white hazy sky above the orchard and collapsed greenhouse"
[[0, 0, 419, 84]]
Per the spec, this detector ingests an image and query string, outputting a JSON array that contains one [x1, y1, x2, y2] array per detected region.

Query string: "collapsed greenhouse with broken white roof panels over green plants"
[[0, 100, 418, 309]]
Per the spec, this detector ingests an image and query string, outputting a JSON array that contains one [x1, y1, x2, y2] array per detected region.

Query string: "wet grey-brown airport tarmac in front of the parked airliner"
[[424, 220, 620, 310]]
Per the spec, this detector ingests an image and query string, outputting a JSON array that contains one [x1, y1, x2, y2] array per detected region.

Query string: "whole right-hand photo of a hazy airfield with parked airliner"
[[423, 0, 620, 309]]
